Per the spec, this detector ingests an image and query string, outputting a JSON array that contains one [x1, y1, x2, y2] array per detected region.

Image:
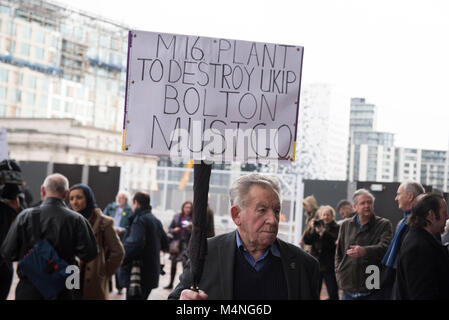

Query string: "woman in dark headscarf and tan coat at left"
[[69, 184, 125, 300]]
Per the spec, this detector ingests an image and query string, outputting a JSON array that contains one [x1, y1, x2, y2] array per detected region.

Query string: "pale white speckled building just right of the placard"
[[295, 83, 349, 180]]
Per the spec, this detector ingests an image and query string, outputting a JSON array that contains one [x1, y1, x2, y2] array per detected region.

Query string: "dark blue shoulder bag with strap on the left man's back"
[[18, 209, 69, 300]]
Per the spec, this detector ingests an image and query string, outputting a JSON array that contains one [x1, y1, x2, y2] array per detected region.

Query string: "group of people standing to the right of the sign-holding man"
[[300, 181, 449, 300]]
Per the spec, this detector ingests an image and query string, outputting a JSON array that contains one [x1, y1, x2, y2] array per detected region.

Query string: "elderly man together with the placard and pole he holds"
[[122, 30, 308, 299]]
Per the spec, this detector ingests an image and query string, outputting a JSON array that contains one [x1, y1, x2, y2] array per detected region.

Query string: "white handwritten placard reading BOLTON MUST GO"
[[122, 30, 304, 163]]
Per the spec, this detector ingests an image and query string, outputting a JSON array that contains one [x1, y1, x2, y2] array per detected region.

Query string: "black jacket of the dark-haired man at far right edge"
[[395, 227, 449, 300]]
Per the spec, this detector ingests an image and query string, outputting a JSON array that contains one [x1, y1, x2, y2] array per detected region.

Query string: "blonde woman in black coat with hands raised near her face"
[[304, 206, 340, 300]]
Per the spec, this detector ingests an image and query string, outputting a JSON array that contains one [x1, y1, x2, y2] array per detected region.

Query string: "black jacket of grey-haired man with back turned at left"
[[0, 198, 98, 264]]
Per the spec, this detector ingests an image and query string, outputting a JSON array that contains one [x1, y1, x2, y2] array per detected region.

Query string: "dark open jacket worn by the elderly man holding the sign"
[[168, 231, 319, 300]]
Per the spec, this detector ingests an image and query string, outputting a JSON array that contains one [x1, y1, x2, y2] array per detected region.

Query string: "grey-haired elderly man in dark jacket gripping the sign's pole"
[[169, 173, 319, 300]]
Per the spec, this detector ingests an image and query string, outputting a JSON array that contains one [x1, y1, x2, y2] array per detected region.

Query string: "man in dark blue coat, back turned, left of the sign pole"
[[119, 192, 168, 300]]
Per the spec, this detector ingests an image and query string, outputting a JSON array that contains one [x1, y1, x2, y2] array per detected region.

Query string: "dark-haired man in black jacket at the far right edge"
[[395, 193, 449, 300]]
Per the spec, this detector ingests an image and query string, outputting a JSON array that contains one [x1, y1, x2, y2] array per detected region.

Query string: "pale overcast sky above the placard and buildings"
[[57, 0, 449, 150]]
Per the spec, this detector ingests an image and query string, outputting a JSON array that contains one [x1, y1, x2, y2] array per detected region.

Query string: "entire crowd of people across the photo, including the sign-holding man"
[[0, 159, 449, 300]]
